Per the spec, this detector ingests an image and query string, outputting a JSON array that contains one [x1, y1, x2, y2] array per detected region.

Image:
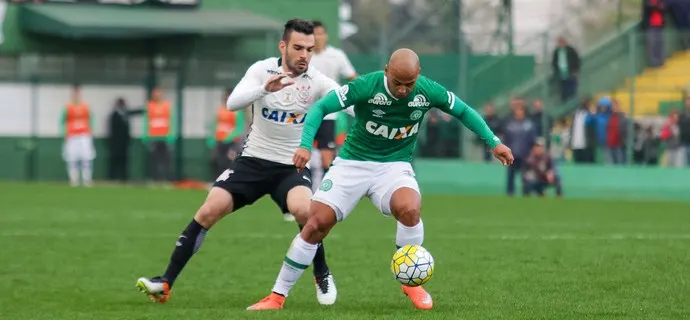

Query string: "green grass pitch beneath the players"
[[0, 183, 690, 320]]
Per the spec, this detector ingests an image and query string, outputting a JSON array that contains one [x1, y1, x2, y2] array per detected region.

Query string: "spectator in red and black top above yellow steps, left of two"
[[642, 0, 666, 67]]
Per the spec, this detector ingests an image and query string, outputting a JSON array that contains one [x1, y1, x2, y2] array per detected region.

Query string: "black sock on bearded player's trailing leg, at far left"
[[163, 219, 208, 288]]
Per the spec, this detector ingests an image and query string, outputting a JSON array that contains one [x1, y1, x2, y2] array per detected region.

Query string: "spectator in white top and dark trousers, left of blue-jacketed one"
[[569, 99, 596, 163]]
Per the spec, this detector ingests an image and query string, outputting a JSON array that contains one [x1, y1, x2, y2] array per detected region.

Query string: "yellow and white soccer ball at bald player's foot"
[[391, 244, 434, 287]]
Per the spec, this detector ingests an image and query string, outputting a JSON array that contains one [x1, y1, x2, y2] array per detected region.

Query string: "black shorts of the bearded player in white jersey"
[[213, 157, 311, 213]]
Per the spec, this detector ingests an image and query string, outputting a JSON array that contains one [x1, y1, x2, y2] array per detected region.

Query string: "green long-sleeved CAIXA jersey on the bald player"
[[300, 71, 500, 162]]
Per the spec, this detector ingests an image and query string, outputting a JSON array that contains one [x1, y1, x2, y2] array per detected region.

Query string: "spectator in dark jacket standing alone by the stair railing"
[[551, 37, 580, 102]]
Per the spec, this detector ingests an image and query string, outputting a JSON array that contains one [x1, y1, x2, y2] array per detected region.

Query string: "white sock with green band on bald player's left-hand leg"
[[273, 234, 319, 297]]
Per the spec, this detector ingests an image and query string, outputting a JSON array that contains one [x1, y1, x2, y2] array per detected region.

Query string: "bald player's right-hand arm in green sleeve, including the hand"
[[440, 91, 514, 165]]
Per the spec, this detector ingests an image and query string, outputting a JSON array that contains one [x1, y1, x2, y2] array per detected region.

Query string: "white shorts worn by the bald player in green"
[[312, 157, 421, 221]]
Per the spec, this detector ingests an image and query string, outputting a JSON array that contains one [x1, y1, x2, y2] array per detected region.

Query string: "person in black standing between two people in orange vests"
[[108, 98, 143, 182]]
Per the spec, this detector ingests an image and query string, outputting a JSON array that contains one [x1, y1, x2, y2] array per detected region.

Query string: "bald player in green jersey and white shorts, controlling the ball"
[[248, 49, 513, 310]]
